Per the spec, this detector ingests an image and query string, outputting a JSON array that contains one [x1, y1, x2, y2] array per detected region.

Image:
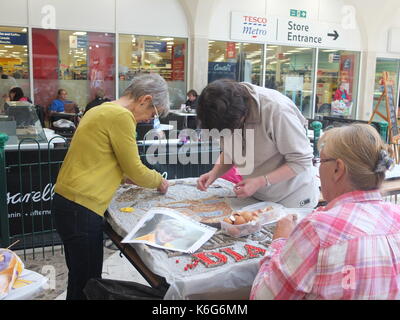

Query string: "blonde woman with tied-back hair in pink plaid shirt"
[[250, 124, 400, 299]]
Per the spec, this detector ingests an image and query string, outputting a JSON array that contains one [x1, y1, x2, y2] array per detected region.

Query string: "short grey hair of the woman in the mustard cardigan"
[[122, 73, 169, 117]]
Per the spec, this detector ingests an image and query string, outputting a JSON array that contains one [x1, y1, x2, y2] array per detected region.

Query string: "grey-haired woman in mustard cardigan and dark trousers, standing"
[[52, 74, 169, 300]]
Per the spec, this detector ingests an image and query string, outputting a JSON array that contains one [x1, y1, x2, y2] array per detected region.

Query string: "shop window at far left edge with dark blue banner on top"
[[0, 27, 30, 109]]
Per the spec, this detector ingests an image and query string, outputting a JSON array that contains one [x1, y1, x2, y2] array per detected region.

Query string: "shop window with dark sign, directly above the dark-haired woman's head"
[[208, 40, 263, 85]]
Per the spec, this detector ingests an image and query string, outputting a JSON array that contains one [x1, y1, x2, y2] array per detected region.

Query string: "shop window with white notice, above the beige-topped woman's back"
[[265, 45, 315, 118]]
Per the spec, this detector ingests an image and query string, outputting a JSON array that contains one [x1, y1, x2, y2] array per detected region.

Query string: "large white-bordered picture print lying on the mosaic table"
[[122, 208, 217, 252]]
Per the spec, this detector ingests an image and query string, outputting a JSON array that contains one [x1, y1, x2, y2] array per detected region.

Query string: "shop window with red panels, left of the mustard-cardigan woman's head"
[[32, 29, 115, 111]]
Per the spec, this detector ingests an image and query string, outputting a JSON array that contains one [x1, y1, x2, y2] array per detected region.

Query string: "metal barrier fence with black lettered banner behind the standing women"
[[0, 134, 220, 259]]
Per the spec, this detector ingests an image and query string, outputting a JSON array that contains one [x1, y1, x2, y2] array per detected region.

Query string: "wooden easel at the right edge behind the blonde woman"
[[368, 71, 400, 163]]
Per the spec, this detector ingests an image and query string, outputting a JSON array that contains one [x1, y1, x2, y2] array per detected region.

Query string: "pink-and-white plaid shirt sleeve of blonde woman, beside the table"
[[250, 220, 319, 300]]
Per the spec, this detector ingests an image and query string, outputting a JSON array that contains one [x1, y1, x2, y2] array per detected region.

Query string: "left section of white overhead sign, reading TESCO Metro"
[[231, 12, 276, 42]]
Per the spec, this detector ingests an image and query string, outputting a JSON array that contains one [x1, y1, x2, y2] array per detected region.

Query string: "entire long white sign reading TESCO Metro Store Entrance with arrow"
[[231, 12, 361, 51]]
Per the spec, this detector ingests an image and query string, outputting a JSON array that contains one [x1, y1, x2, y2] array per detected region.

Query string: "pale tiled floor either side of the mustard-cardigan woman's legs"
[[16, 242, 148, 300]]
